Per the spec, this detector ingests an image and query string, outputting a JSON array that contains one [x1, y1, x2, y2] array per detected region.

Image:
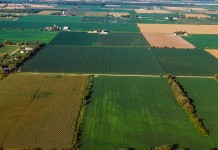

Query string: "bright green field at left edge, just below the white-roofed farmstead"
[[0, 30, 58, 43]]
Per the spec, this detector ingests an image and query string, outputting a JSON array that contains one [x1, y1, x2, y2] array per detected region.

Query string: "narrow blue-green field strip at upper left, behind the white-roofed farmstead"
[[17, 15, 82, 23]]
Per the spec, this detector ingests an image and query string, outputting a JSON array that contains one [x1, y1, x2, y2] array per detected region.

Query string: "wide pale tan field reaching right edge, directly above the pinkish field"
[[138, 24, 218, 34]]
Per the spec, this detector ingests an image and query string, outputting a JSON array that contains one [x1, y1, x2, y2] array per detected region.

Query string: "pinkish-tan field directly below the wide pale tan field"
[[143, 33, 195, 49]]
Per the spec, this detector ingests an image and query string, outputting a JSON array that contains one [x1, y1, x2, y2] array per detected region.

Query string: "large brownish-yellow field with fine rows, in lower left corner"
[[0, 74, 89, 149]]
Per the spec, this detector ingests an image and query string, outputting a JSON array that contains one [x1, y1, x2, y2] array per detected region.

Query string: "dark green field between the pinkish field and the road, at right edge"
[[152, 48, 218, 75]]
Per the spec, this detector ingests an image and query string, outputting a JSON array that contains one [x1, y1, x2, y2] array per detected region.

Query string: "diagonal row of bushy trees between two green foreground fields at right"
[[166, 75, 209, 136]]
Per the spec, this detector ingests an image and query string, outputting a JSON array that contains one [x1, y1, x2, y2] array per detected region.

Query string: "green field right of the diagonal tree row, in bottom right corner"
[[177, 78, 218, 147]]
